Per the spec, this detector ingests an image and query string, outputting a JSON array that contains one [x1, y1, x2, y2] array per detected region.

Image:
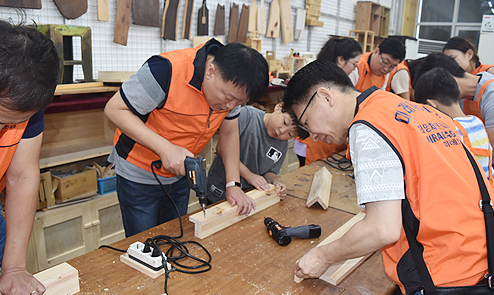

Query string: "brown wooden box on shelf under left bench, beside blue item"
[[52, 170, 98, 203]]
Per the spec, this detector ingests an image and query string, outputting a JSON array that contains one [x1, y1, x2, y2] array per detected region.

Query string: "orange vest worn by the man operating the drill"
[[113, 40, 229, 177]]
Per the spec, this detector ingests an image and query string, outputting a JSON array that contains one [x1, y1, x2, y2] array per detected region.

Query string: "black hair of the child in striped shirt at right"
[[415, 68, 460, 106]]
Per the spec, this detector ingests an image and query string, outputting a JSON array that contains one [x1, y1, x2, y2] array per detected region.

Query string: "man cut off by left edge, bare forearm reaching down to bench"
[[0, 20, 60, 294]]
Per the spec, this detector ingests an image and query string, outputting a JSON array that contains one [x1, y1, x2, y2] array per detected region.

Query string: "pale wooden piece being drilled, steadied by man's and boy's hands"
[[189, 185, 280, 239]]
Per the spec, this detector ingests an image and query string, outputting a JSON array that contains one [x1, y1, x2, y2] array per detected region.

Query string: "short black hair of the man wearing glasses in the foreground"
[[283, 59, 357, 139]]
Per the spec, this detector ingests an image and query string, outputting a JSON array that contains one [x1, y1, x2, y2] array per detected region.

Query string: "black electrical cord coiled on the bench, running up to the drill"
[[99, 160, 212, 294]]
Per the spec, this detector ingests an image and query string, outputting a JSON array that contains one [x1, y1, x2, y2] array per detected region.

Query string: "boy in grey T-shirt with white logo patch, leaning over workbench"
[[208, 103, 297, 203]]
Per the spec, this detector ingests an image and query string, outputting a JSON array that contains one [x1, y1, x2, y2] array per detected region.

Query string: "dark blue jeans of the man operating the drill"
[[117, 175, 190, 237]]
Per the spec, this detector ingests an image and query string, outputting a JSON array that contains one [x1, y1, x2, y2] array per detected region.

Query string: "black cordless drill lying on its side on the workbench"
[[264, 217, 321, 246]]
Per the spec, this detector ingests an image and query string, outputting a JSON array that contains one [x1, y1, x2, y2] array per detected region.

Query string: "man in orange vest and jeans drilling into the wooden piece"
[[105, 39, 268, 236]]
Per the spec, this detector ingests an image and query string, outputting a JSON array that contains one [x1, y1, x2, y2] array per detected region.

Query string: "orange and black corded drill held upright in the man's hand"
[[184, 157, 208, 217]]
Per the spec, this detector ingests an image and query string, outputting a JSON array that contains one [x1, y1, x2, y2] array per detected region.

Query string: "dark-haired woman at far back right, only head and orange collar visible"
[[443, 36, 494, 75]]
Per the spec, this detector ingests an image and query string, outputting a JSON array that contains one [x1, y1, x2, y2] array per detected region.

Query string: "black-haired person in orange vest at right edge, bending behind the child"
[[413, 53, 494, 146]]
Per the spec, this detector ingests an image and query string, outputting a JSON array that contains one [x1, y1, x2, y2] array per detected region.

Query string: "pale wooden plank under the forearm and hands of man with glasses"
[[294, 212, 372, 285]]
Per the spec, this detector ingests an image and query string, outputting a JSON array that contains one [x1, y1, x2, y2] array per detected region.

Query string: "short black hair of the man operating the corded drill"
[[213, 43, 269, 102]]
